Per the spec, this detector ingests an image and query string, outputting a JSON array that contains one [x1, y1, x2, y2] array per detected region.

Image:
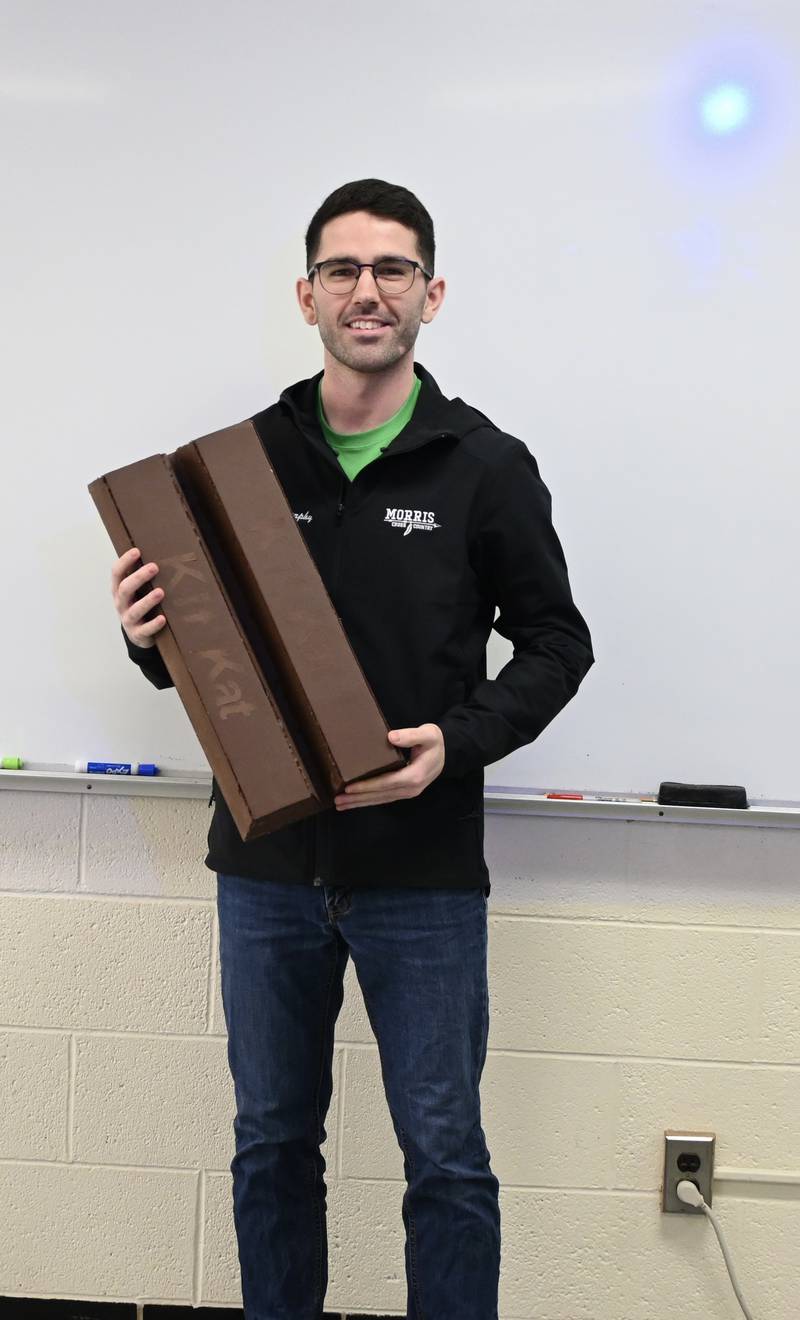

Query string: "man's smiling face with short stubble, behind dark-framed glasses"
[[297, 211, 445, 372]]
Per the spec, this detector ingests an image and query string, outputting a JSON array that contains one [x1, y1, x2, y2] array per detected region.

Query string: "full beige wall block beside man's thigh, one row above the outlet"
[[488, 916, 759, 1060]]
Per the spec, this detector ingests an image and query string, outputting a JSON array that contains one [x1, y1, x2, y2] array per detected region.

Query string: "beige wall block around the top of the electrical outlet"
[[615, 1063, 800, 1191]]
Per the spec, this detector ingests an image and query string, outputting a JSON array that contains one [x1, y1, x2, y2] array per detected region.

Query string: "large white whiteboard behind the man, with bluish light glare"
[[0, 0, 800, 801]]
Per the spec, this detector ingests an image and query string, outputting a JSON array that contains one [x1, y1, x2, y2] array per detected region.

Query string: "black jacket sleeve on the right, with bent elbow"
[[438, 440, 594, 777]]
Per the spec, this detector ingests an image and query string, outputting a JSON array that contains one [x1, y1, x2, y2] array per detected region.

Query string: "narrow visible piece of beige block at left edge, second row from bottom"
[[0, 1031, 69, 1160]]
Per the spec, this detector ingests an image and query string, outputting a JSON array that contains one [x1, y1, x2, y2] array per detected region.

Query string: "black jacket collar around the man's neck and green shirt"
[[279, 362, 486, 454]]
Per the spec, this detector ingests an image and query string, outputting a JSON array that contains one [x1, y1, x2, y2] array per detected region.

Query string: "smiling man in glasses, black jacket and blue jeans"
[[112, 180, 593, 1320]]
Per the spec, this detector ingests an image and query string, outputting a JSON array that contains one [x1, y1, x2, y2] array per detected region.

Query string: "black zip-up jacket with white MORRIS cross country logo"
[[125, 362, 593, 894]]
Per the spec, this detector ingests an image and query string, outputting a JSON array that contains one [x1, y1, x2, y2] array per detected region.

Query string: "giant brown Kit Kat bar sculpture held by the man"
[[88, 421, 405, 840]]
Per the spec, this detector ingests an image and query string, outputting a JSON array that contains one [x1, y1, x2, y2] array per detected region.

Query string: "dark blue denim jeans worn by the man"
[[217, 875, 500, 1320]]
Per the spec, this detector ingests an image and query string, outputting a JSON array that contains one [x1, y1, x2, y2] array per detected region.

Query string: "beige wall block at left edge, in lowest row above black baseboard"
[[0, 1164, 198, 1302]]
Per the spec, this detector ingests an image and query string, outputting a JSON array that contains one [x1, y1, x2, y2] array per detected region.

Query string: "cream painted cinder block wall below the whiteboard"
[[0, 789, 800, 1320]]
